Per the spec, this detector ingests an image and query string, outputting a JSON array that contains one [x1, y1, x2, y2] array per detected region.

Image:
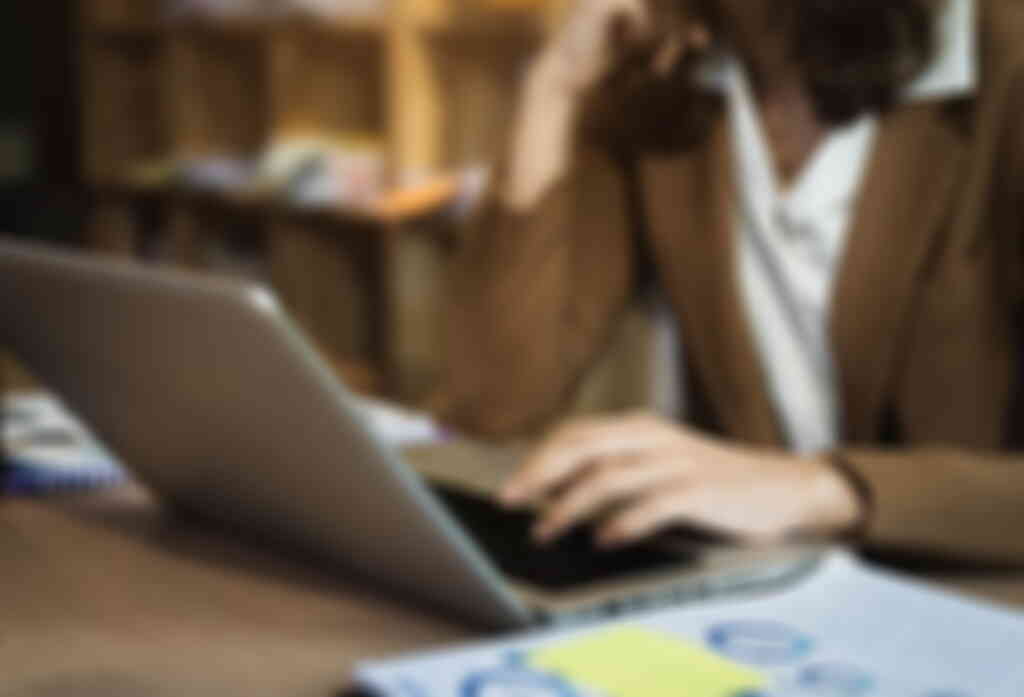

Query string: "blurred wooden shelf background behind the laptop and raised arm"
[[0, 0, 562, 401]]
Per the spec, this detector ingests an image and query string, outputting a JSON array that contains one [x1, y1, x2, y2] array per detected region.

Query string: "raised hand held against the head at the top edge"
[[547, 0, 711, 94]]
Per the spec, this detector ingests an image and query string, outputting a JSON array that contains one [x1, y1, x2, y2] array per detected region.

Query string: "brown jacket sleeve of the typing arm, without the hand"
[[836, 65, 1024, 565]]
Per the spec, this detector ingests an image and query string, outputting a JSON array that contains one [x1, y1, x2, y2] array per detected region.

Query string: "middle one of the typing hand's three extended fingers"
[[535, 454, 683, 542]]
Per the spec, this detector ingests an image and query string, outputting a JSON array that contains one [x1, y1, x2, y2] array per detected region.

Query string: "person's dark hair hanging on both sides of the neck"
[[588, 0, 945, 149]]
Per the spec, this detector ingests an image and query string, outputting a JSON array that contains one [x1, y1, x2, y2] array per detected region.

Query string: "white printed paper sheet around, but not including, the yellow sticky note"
[[356, 551, 1024, 697]]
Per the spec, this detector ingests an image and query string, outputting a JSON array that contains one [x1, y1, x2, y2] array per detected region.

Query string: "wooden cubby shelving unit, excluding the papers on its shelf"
[[81, 0, 556, 398]]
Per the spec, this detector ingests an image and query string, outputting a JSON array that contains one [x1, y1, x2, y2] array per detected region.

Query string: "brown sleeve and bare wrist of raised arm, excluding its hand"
[[442, 59, 633, 436]]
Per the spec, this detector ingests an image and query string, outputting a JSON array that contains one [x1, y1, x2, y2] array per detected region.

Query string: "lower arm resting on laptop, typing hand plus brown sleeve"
[[487, 61, 1024, 566]]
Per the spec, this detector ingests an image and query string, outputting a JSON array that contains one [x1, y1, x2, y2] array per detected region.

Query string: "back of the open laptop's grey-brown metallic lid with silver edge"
[[0, 242, 530, 627]]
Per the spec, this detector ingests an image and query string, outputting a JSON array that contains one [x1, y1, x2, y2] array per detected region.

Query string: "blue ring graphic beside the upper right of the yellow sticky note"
[[707, 621, 814, 665]]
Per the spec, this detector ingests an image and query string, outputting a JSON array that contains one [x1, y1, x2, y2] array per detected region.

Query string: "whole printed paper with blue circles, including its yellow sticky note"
[[356, 551, 1024, 697]]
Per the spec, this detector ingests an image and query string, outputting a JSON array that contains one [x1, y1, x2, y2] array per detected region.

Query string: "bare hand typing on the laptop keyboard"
[[502, 413, 861, 547]]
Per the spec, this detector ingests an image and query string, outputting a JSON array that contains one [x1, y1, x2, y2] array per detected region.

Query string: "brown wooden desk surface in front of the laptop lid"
[[0, 487, 1024, 697]]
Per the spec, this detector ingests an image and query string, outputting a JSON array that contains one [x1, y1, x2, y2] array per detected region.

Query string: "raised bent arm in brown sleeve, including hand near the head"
[[437, 0, 710, 436]]
